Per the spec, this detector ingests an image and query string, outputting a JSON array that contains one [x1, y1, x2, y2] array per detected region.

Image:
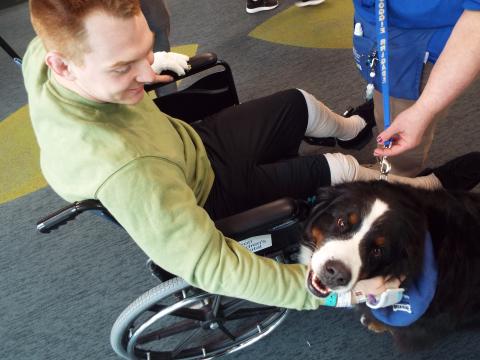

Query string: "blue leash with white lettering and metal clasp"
[[375, 0, 392, 180]]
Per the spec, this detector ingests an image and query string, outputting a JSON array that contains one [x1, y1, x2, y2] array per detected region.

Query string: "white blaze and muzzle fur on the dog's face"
[[311, 199, 388, 291]]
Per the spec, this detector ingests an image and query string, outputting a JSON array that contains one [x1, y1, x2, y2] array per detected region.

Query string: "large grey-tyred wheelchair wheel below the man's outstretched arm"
[[110, 278, 288, 360]]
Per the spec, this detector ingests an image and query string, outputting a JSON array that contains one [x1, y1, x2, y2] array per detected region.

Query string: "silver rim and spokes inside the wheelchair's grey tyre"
[[124, 289, 287, 360]]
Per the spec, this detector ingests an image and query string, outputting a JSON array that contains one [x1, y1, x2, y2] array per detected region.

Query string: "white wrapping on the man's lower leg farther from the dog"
[[298, 89, 366, 140]]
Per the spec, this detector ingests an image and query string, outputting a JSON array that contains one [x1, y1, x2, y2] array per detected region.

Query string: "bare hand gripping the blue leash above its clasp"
[[373, 103, 433, 157]]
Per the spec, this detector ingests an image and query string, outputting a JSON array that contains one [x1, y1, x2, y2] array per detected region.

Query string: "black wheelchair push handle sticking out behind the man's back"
[[37, 200, 105, 234]]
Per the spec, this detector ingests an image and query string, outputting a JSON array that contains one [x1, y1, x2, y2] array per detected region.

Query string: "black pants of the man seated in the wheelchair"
[[194, 89, 330, 219]]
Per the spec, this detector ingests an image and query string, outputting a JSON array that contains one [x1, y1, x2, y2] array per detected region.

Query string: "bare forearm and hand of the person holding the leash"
[[374, 10, 480, 156]]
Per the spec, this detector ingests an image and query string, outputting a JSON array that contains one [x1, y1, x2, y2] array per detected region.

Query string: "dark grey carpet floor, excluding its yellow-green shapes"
[[0, 0, 480, 360]]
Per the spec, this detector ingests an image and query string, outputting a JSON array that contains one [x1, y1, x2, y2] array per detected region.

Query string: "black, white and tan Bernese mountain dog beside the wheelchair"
[[303, 181, 480, 350]]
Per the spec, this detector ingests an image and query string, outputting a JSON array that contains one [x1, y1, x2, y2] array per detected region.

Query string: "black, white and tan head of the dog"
[[302, 181, 426, 297]]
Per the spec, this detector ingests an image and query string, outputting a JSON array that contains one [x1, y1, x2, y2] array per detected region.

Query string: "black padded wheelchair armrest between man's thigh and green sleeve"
[[215, 198, 308, 238]]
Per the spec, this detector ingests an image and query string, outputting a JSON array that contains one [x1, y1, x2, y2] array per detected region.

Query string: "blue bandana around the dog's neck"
[[372, 233, 438, 326]]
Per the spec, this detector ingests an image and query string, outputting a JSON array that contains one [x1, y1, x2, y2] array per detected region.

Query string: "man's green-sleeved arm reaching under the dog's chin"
[[97, 157, 398, 310]]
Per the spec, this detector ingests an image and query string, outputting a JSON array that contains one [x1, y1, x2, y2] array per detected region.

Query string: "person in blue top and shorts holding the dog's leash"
[[353, 0, 480, 176]]
